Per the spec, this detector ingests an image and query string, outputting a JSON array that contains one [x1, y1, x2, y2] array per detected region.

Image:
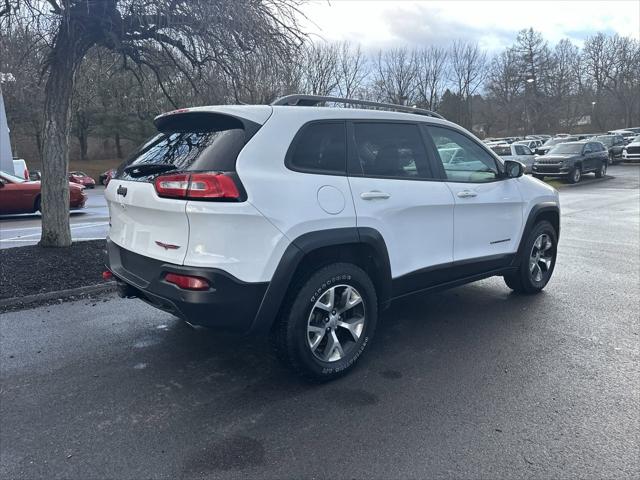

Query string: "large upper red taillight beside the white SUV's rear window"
[[155, 172, 241, 200]]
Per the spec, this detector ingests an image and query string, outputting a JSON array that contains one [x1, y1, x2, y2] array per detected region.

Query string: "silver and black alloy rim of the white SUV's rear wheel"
[[307, 285, 365, 362]]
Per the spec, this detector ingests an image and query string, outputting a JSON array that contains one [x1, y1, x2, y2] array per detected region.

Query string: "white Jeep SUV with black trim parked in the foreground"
[[105, 95, 560, 379]]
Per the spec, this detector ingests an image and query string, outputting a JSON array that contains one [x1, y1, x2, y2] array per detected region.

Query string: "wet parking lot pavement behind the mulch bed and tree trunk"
[[0, 186, 109, 248]]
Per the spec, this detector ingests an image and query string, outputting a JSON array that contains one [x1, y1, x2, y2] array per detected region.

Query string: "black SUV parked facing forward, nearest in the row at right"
[[532, 141, 609, 183]]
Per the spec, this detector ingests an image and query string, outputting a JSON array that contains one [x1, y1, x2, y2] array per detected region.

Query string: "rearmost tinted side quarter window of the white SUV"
[[288, 122, 347, 173]]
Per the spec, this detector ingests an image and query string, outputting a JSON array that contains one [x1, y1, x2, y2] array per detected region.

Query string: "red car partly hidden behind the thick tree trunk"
[[0, 172, 87, 215]]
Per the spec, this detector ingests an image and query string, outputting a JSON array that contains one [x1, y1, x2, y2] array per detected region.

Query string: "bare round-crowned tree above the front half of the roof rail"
[[374, 48, 417, 105]]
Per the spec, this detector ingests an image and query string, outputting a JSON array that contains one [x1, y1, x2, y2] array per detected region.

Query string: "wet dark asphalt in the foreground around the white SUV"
[[0, 166, 640, 479]]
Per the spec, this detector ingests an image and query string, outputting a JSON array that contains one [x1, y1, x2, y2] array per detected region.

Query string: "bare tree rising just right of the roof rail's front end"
[[449, 40, 487, 128]]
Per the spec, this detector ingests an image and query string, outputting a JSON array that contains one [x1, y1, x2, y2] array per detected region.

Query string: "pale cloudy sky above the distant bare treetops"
[[302, 0, 640, 51]]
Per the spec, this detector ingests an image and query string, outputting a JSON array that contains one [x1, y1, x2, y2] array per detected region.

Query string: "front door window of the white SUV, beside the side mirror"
[[428, 126, 499, 183]]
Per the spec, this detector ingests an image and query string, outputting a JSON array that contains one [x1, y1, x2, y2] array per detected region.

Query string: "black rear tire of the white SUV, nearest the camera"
[[271, 263, 378, 382]]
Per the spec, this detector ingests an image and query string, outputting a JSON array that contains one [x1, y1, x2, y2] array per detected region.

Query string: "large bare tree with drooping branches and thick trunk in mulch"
[[0, 0, 301, 247]]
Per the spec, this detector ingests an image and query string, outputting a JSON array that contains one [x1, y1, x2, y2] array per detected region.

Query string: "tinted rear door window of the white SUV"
[[349, 123, 432, 179]]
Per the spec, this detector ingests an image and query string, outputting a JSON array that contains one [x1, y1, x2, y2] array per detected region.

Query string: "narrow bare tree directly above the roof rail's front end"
[[416, 46, 447, 110]]
